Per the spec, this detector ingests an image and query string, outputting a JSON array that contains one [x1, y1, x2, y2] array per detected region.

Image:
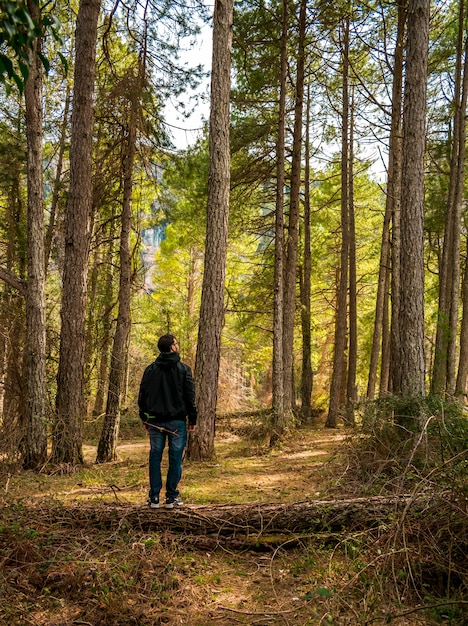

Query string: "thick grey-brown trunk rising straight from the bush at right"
[[395, 0, 430, 396]]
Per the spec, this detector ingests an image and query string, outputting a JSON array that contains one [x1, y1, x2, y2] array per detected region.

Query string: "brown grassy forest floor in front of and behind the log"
[[0, 417, 468, 626]]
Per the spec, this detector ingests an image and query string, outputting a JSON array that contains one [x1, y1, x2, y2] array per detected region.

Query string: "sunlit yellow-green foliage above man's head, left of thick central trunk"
[[133, 141, 208, 365]]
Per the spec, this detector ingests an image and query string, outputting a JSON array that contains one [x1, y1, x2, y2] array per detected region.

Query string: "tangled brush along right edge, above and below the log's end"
[[330, 396, 468, 624]]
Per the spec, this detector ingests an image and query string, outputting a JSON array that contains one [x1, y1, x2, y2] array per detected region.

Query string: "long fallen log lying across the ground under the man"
[[43, 495, 440, 539]]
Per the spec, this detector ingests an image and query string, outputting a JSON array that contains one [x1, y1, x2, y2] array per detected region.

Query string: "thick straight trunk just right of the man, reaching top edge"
[[188, 0, 233, 461]]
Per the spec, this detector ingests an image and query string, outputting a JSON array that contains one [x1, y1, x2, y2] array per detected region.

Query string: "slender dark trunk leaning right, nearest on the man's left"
[[96, 61, 145, 463]]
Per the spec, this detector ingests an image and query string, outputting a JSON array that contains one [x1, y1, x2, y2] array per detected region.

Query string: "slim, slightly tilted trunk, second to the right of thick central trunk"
[[283, 0, 306, 411]]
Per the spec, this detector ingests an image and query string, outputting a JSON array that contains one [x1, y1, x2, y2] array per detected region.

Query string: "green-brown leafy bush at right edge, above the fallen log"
[[346, 396, 468, 497]]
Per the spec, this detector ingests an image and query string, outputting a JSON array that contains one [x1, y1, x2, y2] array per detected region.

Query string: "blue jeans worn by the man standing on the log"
[[148, 420, 187, 498]]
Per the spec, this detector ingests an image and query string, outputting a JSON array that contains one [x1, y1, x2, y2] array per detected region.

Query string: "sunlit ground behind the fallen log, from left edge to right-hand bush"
[[5, 427, 346, 505]]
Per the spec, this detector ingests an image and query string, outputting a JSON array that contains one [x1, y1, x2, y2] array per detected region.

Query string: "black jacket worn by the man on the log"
[[138, 352, 197, 424]]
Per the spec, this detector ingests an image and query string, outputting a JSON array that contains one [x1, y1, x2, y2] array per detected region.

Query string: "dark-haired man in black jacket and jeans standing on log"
[[138, 335, 197, 509]]
